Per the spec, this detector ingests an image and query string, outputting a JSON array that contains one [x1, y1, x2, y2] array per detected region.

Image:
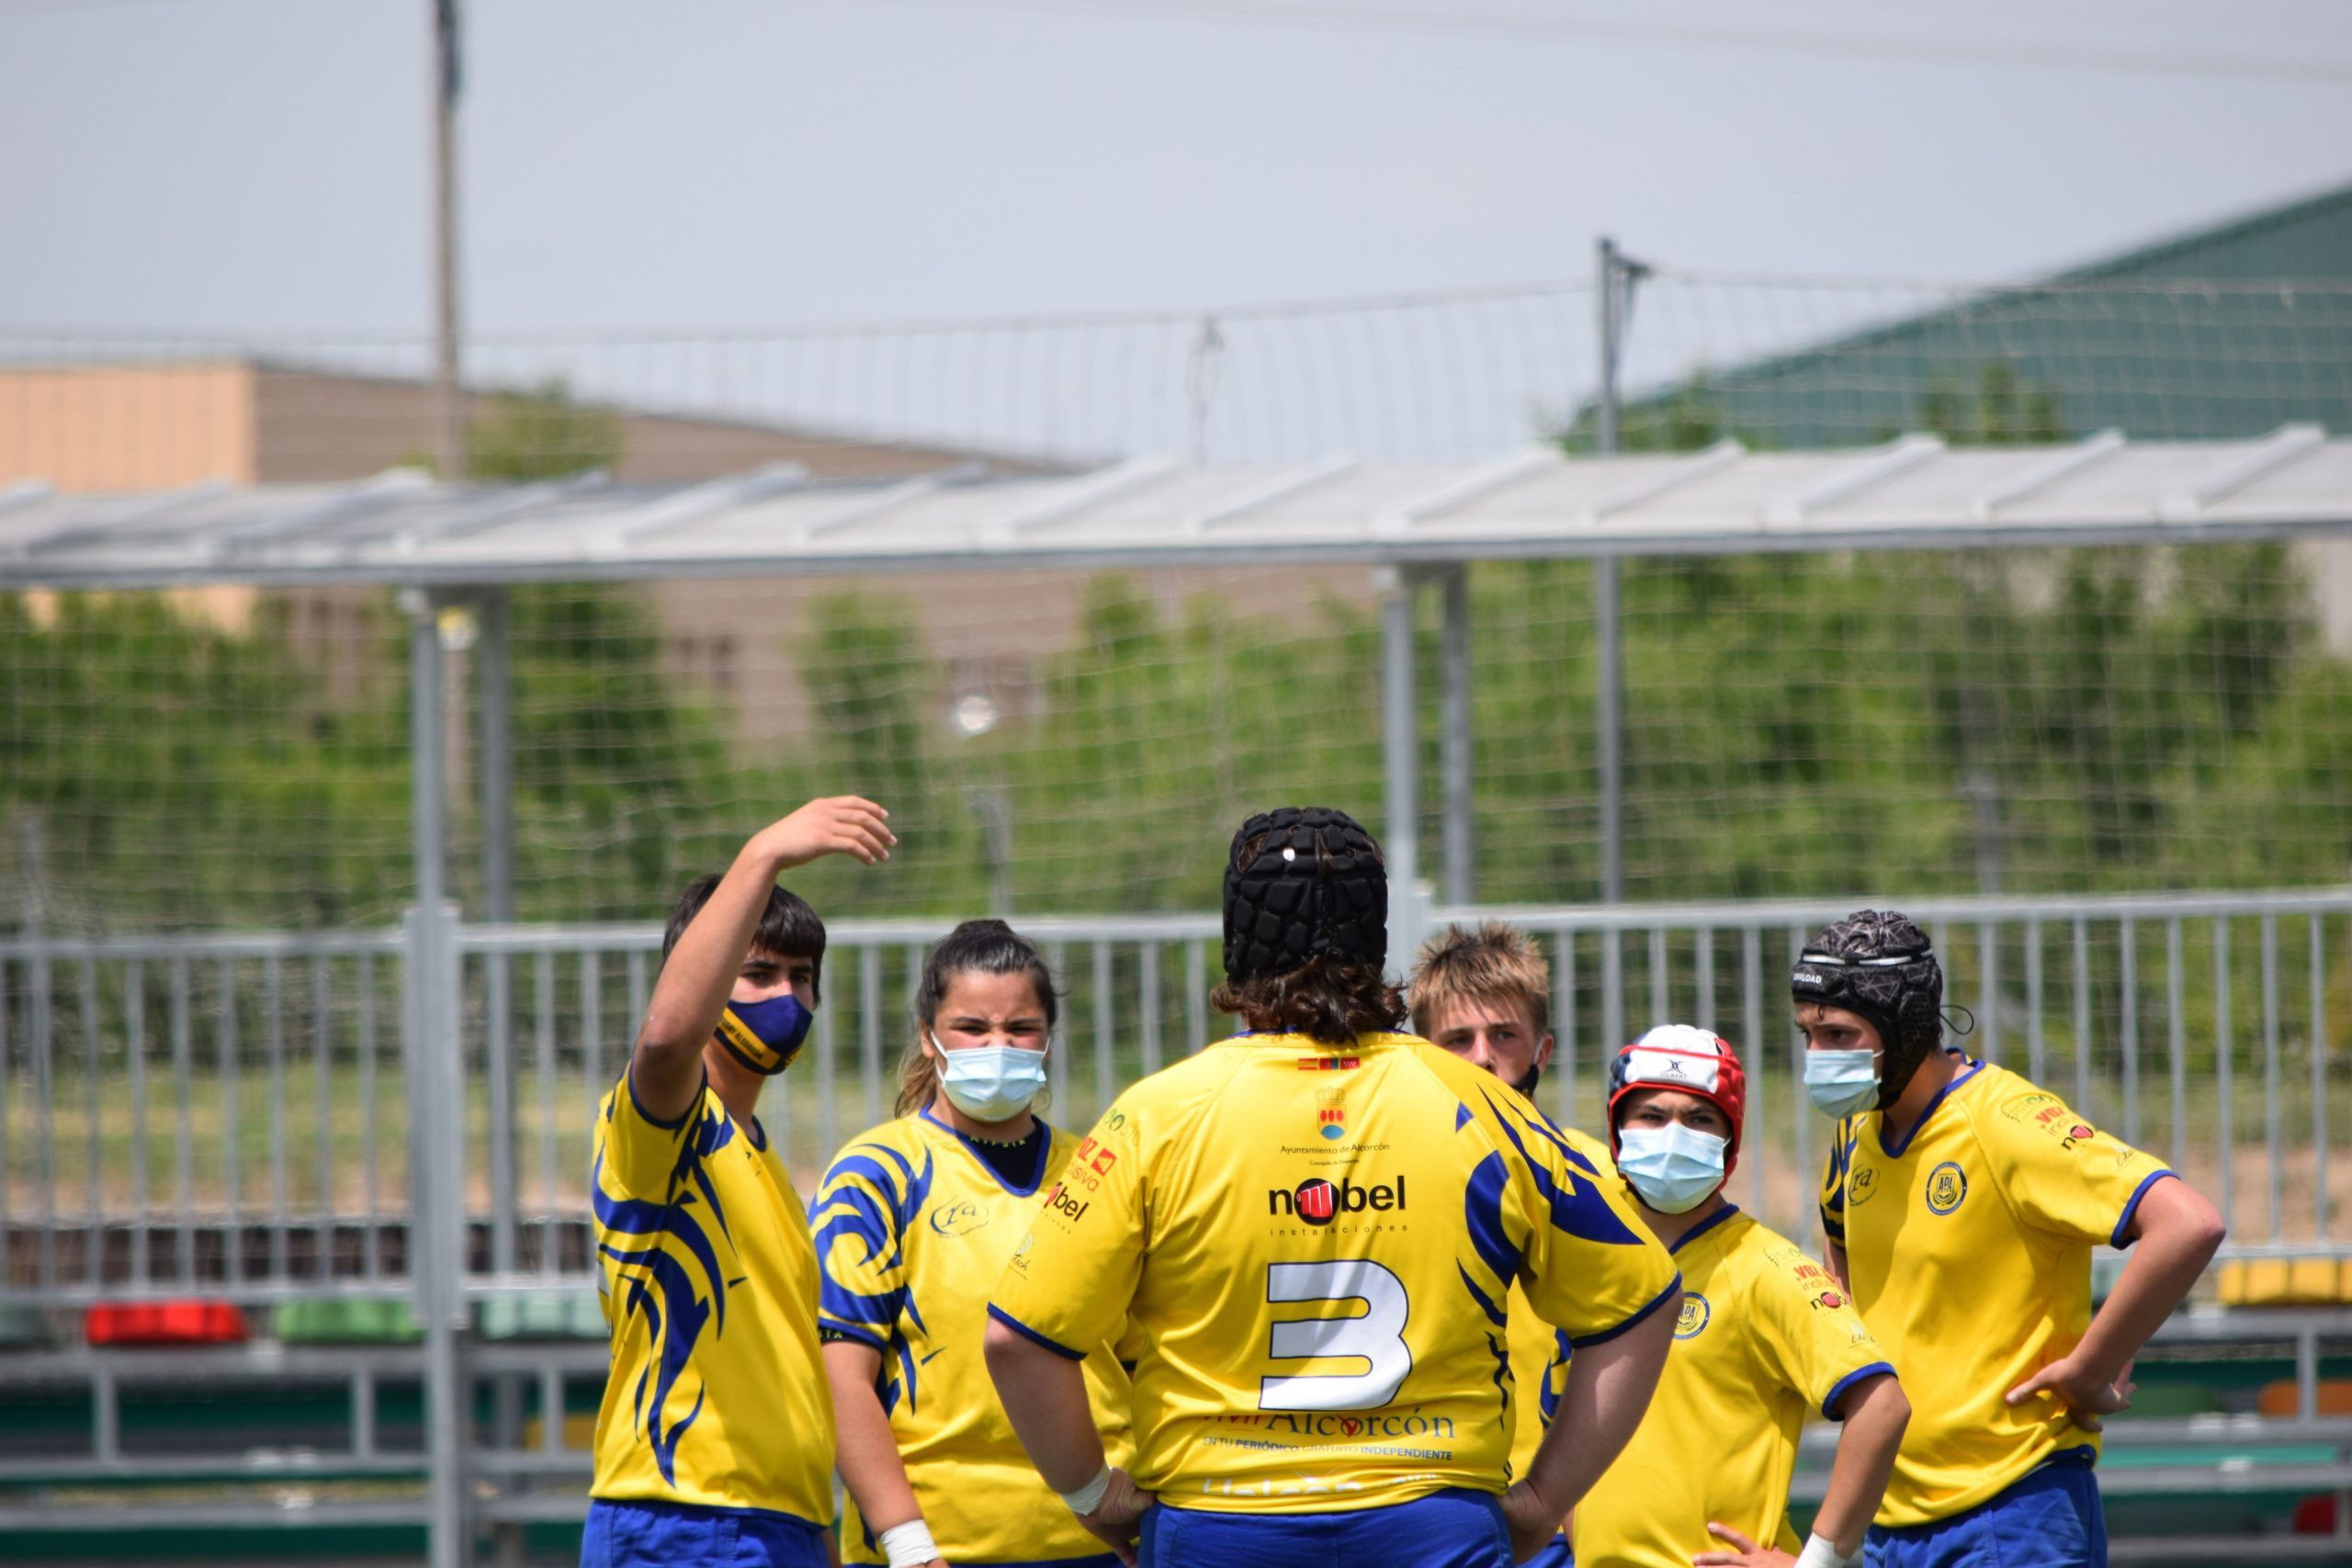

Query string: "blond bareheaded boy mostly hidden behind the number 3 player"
[[1407, 921, 1571, 1568]]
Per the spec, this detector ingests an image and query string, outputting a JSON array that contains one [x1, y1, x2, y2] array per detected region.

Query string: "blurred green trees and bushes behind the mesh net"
[[0, 365, 2352, 929]]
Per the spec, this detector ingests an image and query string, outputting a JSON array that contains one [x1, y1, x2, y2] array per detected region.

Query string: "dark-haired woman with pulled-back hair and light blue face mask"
[[811, 919, 1131, 1568]]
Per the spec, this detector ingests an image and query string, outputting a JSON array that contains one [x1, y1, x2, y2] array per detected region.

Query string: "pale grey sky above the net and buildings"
[[0, 0, 2352, 460]]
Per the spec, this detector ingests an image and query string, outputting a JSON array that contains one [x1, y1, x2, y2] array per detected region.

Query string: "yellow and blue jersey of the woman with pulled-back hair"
[[811, 1112, 1131, 1563]]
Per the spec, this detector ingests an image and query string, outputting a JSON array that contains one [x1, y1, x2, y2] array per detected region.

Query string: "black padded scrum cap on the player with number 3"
[[1226, 807, 1387, 980]]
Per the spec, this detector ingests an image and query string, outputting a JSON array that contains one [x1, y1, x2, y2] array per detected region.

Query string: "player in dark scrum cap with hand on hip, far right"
[[1790, 909, 2222, 1568]]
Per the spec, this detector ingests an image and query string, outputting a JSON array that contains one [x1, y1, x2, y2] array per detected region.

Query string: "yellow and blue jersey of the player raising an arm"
[[588, 1072, 832, 1526]]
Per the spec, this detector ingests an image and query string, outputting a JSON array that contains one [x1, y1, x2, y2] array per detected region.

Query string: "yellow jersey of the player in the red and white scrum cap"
[[1574, 1206, 1894, 1568]]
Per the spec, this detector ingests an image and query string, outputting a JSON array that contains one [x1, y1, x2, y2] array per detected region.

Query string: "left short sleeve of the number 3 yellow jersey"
[[988, 1098, 1150, 1361]]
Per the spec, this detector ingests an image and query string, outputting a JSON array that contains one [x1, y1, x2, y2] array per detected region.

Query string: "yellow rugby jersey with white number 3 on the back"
[[988, 1034, 1677, 1514]]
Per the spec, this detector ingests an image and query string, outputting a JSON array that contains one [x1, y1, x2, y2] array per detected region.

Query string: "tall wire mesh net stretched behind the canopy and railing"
[[0, 275, 2352, 931]]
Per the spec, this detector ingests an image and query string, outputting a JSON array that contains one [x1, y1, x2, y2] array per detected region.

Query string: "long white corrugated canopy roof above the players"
[[0, 425, 2352, 588]]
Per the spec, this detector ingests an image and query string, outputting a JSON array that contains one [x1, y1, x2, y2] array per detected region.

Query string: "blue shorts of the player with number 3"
[[1143, 1491, 1512, 1568]]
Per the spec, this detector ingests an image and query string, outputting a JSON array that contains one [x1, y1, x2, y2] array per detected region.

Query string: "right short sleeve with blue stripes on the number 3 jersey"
[[1463, 1096, 1681, 1347]]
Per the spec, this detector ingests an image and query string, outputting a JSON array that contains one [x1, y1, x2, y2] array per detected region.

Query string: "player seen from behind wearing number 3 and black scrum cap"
[[988, 808, 1679, 1568]]
